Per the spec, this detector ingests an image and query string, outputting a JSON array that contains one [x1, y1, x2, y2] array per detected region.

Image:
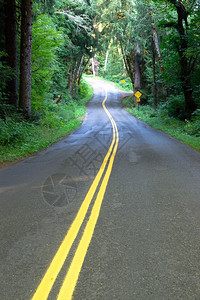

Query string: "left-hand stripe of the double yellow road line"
[[32, 88, 116, 300]]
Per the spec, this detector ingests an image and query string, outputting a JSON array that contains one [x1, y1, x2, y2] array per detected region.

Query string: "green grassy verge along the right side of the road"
[[122, 97, 200, 151]]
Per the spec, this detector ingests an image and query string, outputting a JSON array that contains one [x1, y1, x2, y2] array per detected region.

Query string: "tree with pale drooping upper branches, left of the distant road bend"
[[54, 1, 98, 97]]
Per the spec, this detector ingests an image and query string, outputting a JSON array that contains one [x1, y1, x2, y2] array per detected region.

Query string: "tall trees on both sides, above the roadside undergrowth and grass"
[[0, 0, 200, 118]]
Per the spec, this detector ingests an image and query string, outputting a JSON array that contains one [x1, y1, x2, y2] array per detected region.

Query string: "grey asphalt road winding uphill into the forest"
[[0, 79, 200, 300]]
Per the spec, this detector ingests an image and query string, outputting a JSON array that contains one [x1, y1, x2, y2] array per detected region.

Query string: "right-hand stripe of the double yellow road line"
[[57, 89, 119, 300]]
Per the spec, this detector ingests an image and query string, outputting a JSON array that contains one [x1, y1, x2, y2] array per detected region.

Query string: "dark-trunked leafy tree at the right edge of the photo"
[[154, 0, 199, 119]]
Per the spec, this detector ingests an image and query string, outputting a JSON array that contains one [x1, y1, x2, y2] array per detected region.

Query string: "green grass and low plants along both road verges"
[[0, 77, 200, 166]]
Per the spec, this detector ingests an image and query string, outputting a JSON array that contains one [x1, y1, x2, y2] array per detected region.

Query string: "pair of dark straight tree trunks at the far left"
[[4, 0, 33, 116]]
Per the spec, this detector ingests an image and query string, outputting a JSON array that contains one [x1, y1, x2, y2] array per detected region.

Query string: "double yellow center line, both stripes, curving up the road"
[[32, 91, 119, 300]]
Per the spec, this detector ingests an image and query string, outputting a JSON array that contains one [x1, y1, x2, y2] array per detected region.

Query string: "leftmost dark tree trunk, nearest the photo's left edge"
[[4, 0, 18, 107]]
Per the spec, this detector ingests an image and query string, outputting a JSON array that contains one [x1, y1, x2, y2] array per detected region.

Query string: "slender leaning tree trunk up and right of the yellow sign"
[[149, 8, 167, 101]]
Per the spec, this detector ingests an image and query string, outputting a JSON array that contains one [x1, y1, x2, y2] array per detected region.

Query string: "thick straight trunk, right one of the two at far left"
[[19, 0, 33, 116]]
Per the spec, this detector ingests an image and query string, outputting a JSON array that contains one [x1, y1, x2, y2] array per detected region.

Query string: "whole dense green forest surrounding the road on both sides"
[[0, 0, 200, 163]]
